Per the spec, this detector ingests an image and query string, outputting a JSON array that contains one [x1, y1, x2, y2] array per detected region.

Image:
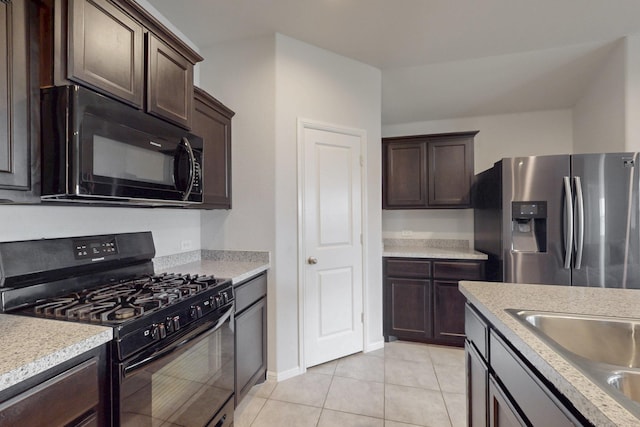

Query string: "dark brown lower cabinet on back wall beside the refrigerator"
[[383, 257, 484, 346]]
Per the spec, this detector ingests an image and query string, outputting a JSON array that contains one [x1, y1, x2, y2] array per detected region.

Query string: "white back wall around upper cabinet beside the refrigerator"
[[382, 110, 573, 242]]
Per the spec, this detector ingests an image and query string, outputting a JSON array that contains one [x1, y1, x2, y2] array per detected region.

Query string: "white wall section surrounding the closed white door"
[[275, 35, 383, 373]]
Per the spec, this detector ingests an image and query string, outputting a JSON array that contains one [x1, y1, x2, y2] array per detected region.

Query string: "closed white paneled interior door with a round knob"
[[302, 123, 363, 367]]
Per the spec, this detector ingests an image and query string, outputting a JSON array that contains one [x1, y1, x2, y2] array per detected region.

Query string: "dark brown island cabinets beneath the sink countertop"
[[465, 305, 591, 427]]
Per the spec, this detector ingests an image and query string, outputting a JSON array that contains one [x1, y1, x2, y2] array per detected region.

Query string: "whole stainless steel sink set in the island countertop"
[[507, 309, 640, 417]]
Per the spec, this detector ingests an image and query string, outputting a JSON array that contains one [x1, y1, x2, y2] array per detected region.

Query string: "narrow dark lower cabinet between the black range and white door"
[[235, 273, 267, 406]]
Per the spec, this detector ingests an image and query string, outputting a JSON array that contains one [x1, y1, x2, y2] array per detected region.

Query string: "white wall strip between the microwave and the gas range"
[[0, 205, 200, 256]]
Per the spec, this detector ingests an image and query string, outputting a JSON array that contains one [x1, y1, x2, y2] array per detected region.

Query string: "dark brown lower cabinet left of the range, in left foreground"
[[0, 348, 110, 427]]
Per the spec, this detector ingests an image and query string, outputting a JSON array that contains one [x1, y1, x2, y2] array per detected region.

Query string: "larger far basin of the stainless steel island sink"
[[513, 311, 640, 368]]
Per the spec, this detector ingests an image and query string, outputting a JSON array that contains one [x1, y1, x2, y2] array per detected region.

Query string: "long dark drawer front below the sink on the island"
[[489, 331, 580, 427]]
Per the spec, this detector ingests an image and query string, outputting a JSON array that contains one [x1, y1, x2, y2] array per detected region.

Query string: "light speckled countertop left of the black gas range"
[[0, 314, 113, 390]]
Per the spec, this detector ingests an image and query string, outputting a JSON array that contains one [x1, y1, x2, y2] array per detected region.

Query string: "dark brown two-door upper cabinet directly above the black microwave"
[[61, 0, 202, 129]]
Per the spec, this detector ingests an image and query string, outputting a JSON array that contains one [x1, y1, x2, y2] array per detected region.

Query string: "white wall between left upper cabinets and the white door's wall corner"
[[200, 36, 278, 372]]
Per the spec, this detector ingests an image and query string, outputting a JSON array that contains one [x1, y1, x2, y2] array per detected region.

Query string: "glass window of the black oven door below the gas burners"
[[119, 321, 234, 426]]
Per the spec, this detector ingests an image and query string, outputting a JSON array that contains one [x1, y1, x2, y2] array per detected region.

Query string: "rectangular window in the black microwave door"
[[93, 134, 174, 186]]
